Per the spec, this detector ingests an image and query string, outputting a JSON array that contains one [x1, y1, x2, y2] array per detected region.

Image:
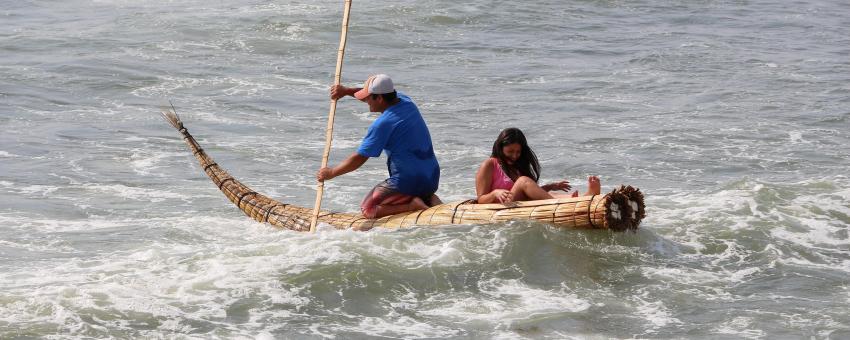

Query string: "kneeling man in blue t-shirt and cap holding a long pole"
[[316, 74, 442, 218]]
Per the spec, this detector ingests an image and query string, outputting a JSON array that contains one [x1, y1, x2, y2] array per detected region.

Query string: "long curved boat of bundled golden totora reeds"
[[162, 109, 645, 231]]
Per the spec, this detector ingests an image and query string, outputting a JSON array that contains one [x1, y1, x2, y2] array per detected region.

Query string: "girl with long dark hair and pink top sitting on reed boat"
[[475, 128, 600, 203]]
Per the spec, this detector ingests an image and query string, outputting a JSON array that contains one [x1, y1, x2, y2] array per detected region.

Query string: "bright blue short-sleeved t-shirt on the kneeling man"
[[357, 92, 440, 196]]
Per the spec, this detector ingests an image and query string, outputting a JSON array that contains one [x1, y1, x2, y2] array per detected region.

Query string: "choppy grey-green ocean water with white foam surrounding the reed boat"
[[0, 0, 850, 339]]
